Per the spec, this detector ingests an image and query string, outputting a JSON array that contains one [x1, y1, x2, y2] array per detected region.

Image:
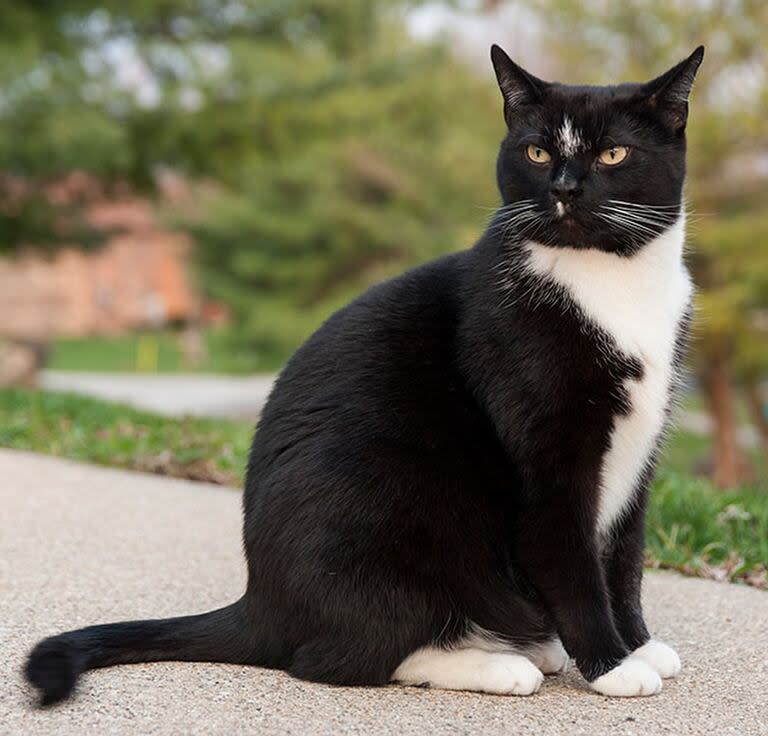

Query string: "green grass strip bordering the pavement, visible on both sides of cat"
[[0, 390, 768, 587]]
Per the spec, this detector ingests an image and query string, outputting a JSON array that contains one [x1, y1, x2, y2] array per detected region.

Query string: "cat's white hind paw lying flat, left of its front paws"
[[392, 646, 544, 695]]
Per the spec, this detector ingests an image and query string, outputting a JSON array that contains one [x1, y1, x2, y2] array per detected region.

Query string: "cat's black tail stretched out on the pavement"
[[25, 600, 252, 705]]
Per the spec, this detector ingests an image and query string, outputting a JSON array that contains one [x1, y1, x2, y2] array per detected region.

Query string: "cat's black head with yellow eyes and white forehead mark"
[[491, 45, 704, 255]]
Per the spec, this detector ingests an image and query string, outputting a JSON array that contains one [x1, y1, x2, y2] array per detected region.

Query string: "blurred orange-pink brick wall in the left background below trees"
[[0, 200, 200, 339]]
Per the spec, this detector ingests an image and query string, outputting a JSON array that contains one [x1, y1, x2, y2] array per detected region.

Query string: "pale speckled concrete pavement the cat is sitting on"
[[0, 450, 768, 736]]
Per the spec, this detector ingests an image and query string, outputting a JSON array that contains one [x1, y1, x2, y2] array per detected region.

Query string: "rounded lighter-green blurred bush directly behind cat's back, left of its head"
[[181, 16, 502, 350]]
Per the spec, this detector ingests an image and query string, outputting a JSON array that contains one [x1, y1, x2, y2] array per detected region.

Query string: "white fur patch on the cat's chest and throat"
[[527, 216, 692, 533]]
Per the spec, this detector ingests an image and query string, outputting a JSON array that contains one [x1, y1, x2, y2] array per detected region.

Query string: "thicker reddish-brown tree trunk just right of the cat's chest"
[[701, 350, 745, 488]]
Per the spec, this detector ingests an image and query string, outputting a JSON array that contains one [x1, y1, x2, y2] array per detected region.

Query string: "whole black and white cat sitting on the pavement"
[[26, 46, 703, 703]]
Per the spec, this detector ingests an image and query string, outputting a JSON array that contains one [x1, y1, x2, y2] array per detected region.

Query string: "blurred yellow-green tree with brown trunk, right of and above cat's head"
[[504, 0, 768, 487]]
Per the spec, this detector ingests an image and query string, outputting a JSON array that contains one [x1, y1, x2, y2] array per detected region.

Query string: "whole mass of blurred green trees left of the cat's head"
[[0, 0, 503, 358]]
